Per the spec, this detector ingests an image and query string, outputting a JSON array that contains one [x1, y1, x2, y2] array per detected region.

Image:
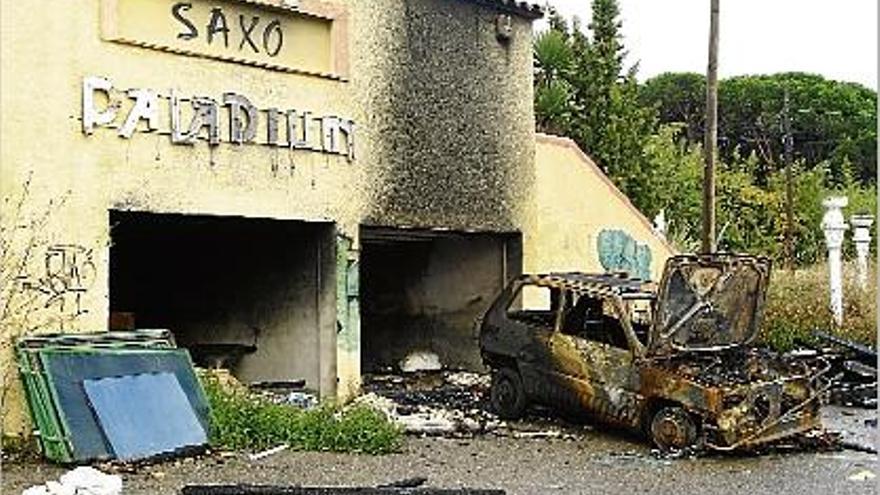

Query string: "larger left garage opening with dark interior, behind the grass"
[[110, 211, 335, 390]]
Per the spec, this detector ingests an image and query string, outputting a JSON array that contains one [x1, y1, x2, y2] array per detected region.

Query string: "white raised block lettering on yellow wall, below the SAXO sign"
[[82, 77, 355, 161]]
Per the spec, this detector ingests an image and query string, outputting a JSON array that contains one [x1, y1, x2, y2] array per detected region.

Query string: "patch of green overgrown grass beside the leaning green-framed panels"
[[200, 374, 403, 454]]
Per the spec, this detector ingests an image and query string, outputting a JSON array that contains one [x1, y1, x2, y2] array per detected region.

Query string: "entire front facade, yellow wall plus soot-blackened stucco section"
[[0, 0, 534, 432]]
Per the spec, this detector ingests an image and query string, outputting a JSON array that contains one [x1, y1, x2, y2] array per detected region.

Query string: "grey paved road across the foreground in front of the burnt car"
[[3, 409, 878, 495]]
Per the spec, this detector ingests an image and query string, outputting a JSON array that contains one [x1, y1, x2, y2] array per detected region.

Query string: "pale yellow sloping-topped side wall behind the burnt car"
[[523, 134, 674, 280]]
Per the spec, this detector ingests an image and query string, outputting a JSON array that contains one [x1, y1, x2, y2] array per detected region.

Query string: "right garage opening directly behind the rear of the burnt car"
[[360, 227, 522, 373]]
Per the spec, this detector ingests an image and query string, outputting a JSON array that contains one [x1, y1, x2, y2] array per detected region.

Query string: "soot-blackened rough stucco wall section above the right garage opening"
[[366, 0, 534, 230]]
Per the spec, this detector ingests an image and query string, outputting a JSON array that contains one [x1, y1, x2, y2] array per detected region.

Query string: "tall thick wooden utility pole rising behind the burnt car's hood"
[[703, 0, 720, 253]]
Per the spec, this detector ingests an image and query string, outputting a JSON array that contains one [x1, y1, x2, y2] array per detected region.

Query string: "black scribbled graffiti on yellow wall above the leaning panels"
[[22, 244, 95, 317]]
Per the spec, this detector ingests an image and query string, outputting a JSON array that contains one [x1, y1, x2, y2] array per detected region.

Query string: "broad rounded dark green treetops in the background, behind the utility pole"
[[640, 73, 877, 185]]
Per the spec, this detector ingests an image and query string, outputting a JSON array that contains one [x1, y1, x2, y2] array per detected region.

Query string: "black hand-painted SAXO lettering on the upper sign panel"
[[171, 2, 284, 57]]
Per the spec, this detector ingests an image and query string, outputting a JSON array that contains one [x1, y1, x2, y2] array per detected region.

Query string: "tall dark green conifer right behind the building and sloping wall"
[[535, 0, 654, 194]]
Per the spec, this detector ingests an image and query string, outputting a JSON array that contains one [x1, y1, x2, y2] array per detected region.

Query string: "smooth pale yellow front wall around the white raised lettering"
[[0, 0, 362, 432]]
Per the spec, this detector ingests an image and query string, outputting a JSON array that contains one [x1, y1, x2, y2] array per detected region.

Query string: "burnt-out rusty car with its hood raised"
[[479, 254, 824, 451]]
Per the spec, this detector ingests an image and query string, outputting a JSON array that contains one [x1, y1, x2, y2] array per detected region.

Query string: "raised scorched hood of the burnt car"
[[648, 254, 770, 354]]
